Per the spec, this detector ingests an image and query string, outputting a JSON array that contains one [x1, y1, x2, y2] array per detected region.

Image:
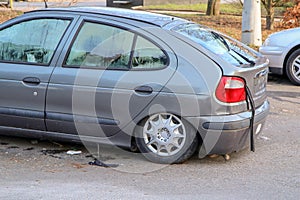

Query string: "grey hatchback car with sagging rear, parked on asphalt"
[[0, 7, 269, 163]]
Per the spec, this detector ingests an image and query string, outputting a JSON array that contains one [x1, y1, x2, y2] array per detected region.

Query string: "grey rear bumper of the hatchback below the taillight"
[[187, 101, 270, 157]]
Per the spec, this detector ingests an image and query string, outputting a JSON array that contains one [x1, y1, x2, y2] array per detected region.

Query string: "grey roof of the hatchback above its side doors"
[[30, 7, 186, 27]]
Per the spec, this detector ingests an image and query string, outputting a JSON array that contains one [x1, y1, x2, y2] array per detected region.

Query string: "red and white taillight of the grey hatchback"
[[216, 76, 246, 103]]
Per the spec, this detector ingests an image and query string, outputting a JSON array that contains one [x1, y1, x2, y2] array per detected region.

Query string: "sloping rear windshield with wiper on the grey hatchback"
[[172, 23, 256, 67]]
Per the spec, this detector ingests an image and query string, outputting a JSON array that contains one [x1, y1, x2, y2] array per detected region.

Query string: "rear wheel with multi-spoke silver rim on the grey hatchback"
[[136, 113, 198, 164]]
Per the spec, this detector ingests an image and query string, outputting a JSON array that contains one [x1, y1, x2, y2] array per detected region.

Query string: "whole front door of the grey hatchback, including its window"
[[0, 14, 76, 130]]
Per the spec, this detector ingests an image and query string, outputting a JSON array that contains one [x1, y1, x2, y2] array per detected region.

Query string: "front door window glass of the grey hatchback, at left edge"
[[0, 19, 70, 65]]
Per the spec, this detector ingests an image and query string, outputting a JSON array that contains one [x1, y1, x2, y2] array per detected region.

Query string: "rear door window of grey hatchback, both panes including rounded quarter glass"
[[64, 22, 168, 70]]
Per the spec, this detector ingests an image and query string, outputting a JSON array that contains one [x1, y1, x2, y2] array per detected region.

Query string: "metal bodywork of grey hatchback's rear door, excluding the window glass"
[[46, 17, 177, 137]]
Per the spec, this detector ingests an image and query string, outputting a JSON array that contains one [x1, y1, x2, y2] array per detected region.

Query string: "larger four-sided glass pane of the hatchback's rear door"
[[65, 22, 134, 69]]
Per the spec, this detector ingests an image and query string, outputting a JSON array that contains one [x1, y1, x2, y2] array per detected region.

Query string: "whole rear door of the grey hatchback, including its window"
[[46, 17, 177, 137]]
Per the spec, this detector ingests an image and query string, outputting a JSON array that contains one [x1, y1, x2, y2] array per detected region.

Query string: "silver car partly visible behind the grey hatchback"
[[259, 28, 300, 85]]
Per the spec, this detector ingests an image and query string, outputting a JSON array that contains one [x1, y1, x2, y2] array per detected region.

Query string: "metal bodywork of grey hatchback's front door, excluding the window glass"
[[0, 14, 79, 130]]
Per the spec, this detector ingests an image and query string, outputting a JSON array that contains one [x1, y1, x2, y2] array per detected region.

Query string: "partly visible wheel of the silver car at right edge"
[[286, 49, 300, 85]]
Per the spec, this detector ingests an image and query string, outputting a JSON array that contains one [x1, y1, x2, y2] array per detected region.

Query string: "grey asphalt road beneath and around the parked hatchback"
[[0, 76, 300, 200]]
